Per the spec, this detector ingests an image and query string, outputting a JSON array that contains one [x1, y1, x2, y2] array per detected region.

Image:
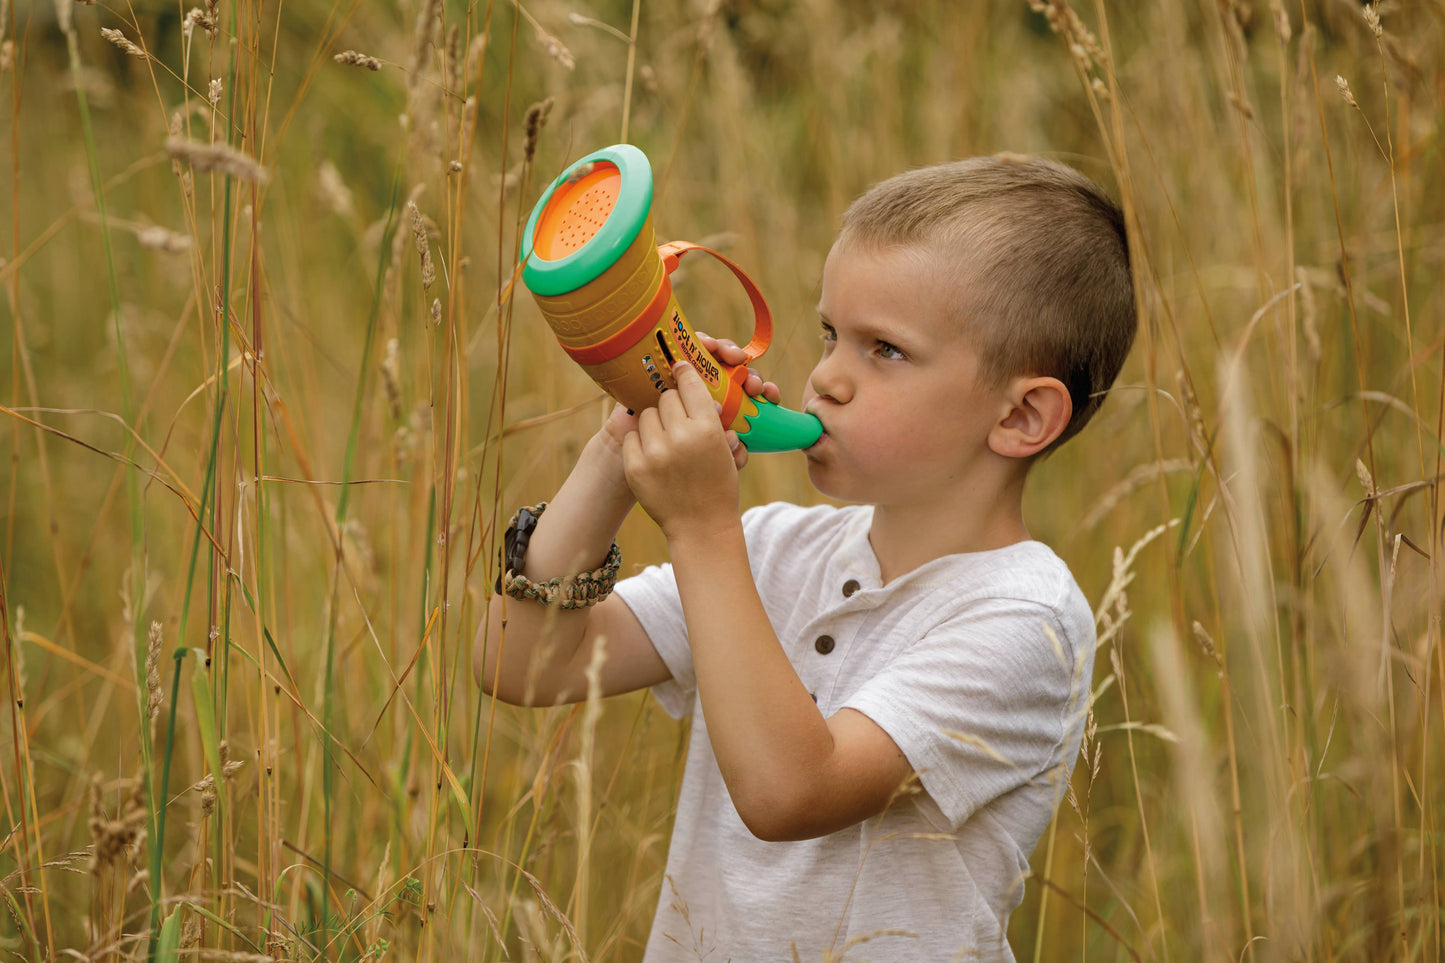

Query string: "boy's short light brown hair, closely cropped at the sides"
[[838, 153, 1137, 451]]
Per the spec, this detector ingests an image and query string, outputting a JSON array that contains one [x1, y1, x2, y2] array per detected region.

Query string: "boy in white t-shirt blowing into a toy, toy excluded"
[[477, 155, 1136, 963]]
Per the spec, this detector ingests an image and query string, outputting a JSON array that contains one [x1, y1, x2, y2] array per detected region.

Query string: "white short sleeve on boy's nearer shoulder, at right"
[[842, 599, 1092, 829]]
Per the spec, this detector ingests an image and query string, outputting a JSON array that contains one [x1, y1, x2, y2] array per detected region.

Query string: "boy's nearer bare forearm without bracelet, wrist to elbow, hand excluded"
[[669, 518, 834, 837]]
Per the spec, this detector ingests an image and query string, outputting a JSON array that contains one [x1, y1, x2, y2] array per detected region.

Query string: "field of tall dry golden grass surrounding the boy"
[[0, 0, 1445, 963]]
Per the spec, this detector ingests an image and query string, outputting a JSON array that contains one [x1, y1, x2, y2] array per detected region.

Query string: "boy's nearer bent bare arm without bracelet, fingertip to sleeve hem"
[[623, 369, 912, 840]]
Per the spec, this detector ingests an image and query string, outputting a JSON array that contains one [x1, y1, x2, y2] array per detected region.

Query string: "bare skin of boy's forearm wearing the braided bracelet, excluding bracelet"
[[475, 434, 633, 704]]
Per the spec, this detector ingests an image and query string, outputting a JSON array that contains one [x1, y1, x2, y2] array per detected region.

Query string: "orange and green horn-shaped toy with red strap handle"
[[522, 145, 822, 453]]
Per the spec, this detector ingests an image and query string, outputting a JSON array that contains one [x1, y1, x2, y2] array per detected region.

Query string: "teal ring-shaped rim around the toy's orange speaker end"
[[522, 143, 652, 296]]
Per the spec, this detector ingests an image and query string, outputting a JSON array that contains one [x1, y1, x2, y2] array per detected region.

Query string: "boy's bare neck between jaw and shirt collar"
[[868, 462, 1029, 583]]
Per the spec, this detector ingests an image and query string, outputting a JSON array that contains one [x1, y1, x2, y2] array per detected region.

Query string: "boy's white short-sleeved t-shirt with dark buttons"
[[617, 503, 1095, 963]]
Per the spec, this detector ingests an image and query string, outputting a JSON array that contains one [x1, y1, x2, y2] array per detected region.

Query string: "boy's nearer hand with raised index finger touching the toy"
[[623, 361, 741, 539]]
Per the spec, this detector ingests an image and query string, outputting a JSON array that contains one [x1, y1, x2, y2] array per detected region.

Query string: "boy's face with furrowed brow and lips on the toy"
[[803, 243, 1010, 508]]
